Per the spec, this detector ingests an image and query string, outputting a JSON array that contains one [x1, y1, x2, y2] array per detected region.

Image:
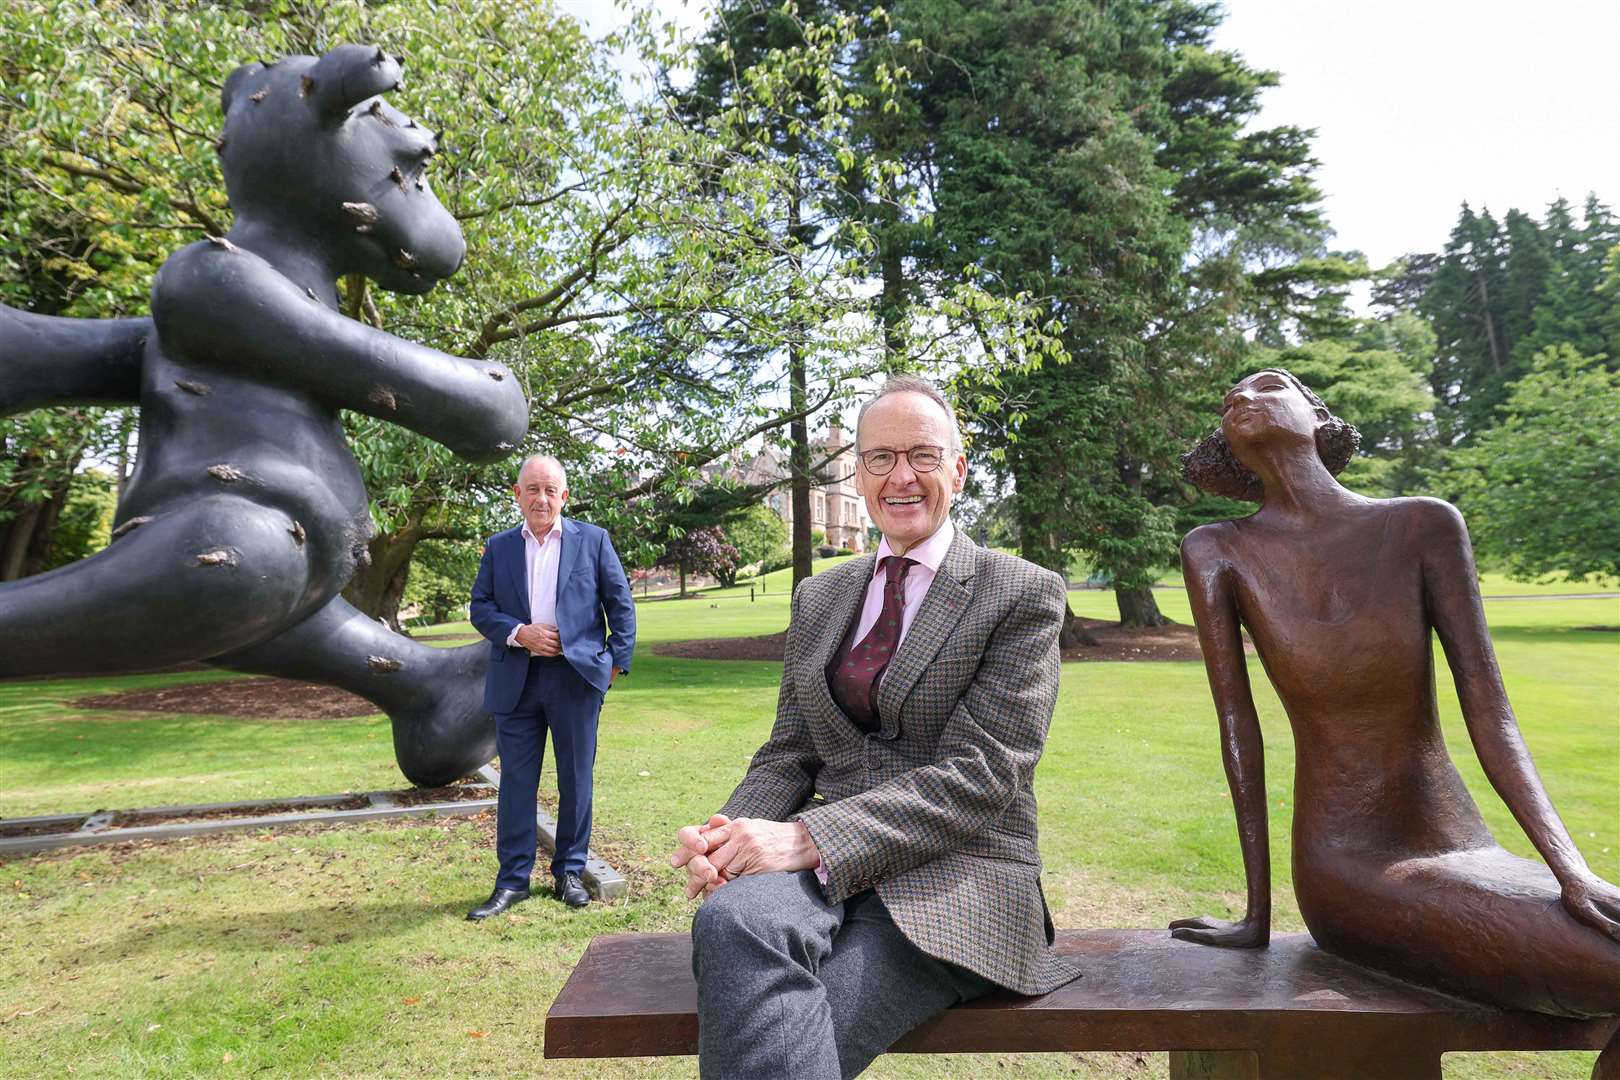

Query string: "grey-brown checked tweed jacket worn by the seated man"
[[719, 531, 1079, 994]]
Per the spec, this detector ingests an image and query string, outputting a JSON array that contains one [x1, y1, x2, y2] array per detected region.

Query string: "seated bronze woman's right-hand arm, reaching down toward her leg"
[[1414, 499, 1592, 886]]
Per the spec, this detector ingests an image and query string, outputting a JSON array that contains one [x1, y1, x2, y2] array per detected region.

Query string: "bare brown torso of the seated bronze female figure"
[[1223, 499, 1494, 874]]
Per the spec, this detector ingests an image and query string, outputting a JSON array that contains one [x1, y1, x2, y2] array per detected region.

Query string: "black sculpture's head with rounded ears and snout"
[[219, 45, 467, 293]]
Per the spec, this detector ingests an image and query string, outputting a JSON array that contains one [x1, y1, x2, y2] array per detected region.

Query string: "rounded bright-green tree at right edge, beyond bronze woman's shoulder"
[[1445, 345, 1620, 578]]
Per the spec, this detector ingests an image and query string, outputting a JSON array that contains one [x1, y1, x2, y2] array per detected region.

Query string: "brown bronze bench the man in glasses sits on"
[[546, 929, 1620, 1080]]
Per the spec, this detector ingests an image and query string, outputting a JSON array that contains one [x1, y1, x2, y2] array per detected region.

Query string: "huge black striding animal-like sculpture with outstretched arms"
[[0, 45, 528, 785]]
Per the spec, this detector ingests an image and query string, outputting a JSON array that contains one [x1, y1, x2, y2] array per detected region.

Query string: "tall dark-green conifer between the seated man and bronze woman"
[[894, 0, 1354, 628]]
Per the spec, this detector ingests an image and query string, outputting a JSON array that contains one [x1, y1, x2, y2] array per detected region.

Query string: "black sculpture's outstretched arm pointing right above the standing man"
[[152, 243, 528, 461]]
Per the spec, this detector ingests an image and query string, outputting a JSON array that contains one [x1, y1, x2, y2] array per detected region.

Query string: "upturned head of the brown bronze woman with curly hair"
[[1181, 368, 1361, 502]]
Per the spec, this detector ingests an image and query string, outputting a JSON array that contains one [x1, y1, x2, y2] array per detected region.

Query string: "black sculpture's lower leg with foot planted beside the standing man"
[[209, 597, 496, 787]]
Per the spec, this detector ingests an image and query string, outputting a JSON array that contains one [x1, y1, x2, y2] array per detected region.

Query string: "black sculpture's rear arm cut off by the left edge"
[[0, 304, 152, 416]]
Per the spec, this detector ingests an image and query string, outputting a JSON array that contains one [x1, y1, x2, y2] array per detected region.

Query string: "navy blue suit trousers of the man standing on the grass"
[[496, 656, 603, 889]]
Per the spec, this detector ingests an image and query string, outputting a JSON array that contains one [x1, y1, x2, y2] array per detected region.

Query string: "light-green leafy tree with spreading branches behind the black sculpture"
[[0, 0, 933, 617]]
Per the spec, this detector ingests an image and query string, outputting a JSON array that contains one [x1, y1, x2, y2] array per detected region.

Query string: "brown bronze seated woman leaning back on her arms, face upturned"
[[1171, 371, 1620, 1075]]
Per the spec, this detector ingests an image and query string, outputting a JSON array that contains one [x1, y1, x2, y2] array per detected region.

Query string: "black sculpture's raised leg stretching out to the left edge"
[[0, 495, 311, 677]]
